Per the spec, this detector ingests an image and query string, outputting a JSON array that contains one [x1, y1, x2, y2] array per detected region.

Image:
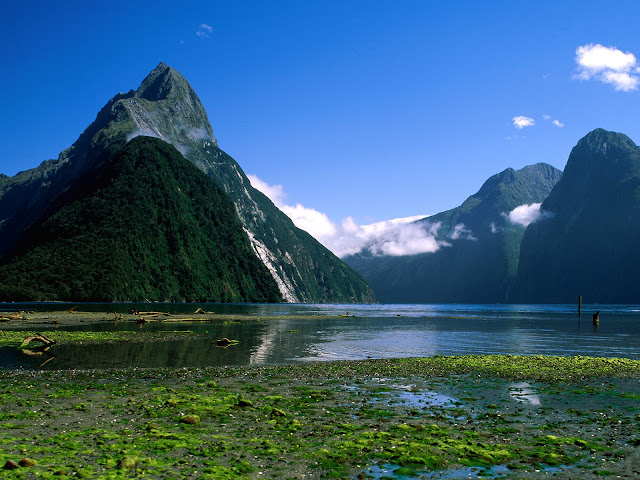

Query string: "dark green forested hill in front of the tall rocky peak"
[[0, 137, 281, 302]]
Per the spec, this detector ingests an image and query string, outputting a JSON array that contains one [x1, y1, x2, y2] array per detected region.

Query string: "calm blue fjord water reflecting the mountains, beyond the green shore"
[[0, 304, 640, 369]]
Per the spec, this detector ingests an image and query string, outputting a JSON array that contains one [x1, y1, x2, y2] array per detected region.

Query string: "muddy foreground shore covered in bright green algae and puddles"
[[0, 356, 640, 479]]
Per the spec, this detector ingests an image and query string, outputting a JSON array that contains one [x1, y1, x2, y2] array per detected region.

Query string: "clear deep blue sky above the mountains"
[[0, 0, 640, 233]]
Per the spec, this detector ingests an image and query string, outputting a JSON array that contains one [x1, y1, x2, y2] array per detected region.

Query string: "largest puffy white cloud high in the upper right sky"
[[573, 43, 640, 92]]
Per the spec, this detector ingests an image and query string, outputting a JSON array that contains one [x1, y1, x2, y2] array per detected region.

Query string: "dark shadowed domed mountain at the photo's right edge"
[[516, 129, 640, 303]]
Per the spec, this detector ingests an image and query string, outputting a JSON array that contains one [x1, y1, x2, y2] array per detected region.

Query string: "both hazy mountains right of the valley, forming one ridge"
[[345, 128, 640, 304]]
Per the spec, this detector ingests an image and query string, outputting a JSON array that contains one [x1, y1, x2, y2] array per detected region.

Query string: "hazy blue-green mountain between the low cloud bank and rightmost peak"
[[345, 163, 562, 303]]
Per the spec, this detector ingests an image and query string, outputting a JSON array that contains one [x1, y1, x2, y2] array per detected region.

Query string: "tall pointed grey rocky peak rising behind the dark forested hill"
[[0, 63, 375, 302]]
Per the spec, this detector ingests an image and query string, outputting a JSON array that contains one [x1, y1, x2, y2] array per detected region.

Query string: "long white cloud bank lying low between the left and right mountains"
[[247, 175, 447, 257]]
